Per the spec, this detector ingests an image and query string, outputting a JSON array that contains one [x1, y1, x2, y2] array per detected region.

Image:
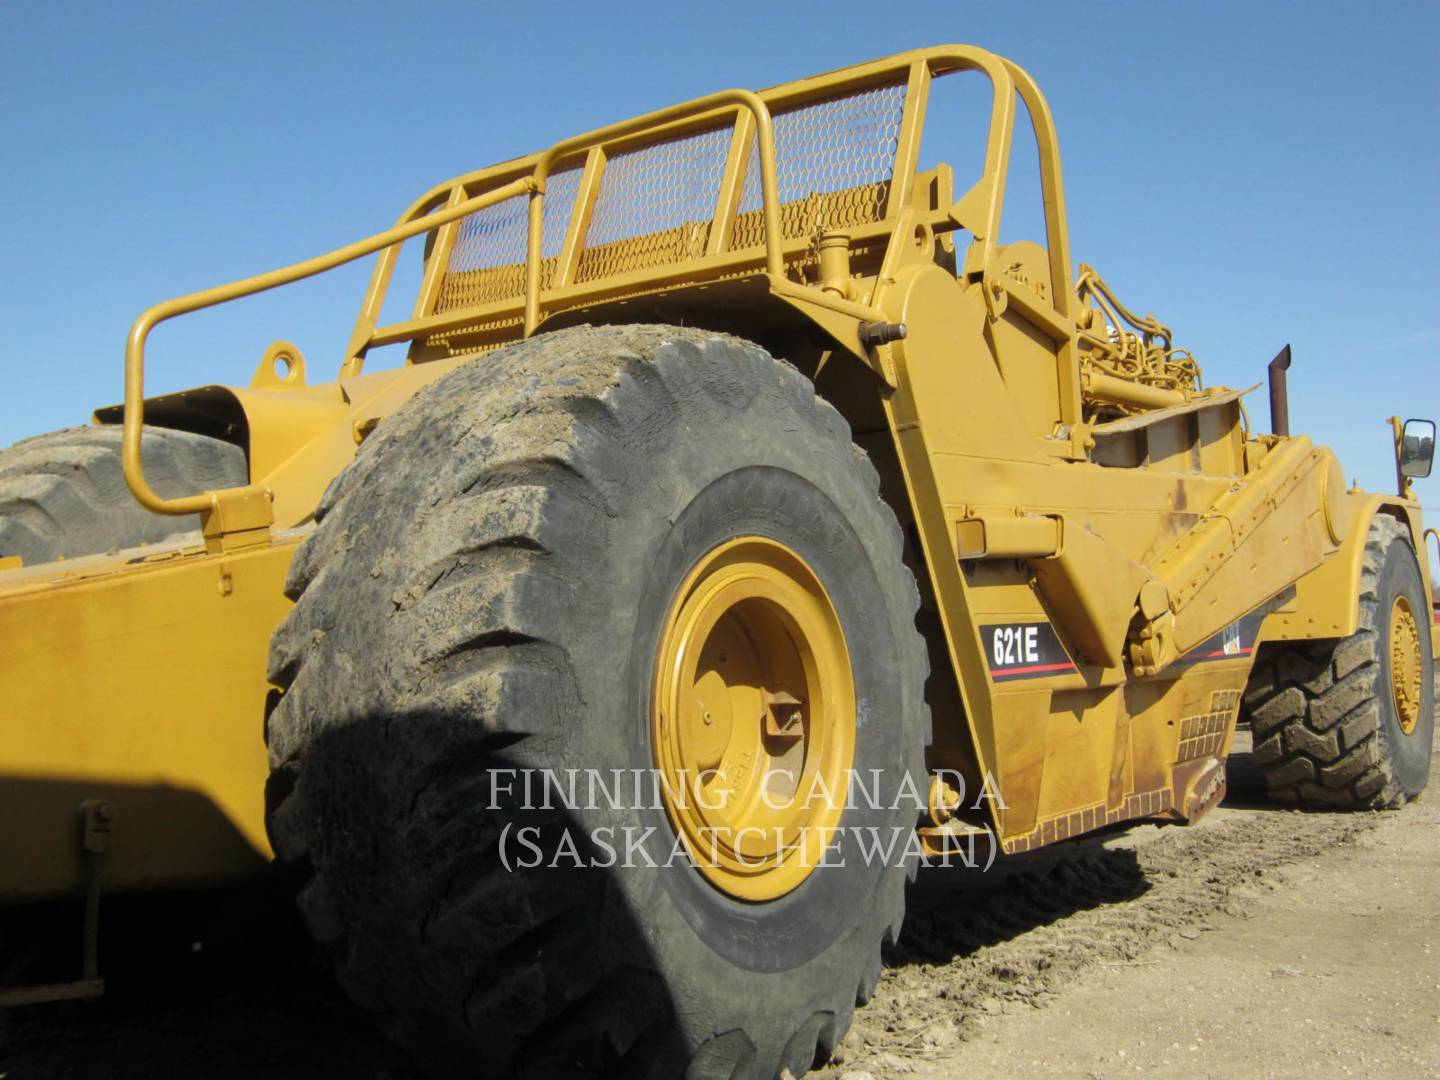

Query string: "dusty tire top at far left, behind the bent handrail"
[[0, 425, 248, 566]]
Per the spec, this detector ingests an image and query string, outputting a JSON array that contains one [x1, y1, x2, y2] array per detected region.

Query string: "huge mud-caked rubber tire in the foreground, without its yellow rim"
[[268, 327, 927, 1079]]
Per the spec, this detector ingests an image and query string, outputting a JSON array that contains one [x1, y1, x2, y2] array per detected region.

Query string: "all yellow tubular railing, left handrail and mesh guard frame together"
[[122, 46, 1079, 537]]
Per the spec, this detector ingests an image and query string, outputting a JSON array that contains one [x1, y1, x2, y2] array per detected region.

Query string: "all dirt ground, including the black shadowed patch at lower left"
[[0, 753, 1440, 1080]]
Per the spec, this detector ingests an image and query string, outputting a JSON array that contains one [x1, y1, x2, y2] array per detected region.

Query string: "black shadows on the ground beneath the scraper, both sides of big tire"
[[0, 753, 1284, 1080]]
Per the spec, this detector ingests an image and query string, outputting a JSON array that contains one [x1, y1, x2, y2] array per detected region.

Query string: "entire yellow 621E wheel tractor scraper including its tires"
[[0, 46, 1437, 1077]]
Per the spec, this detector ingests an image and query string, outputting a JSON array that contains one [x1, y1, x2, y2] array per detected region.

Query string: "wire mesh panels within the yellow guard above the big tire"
[[435, 84, 906, 321]]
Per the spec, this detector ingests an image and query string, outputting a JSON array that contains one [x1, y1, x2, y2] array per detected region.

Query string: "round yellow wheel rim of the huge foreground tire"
[[651, 537, 855, 900]]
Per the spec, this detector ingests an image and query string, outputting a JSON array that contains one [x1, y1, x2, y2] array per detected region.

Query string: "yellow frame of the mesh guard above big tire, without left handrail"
[[351, 46, 1036, 374]]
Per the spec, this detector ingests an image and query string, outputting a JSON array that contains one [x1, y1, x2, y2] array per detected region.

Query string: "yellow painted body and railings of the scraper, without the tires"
[[0, 46, 1436, 894]]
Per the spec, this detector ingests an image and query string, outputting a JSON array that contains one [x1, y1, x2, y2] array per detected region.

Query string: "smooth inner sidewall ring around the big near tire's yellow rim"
[[607, 467, 916, 972]]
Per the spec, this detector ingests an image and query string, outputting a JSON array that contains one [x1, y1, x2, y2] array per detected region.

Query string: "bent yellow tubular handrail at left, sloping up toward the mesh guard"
[[121, 176, 534, 514]]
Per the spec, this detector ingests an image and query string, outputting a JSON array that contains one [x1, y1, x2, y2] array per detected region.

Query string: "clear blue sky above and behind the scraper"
[[0, 0, 1440, 552]]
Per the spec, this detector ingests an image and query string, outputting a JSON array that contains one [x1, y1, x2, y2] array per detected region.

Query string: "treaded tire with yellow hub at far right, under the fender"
[[1246, 514, 1436, 809]]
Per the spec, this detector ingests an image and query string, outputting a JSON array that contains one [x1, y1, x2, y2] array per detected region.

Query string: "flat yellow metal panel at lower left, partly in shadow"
[[0, 534, 300, 900]]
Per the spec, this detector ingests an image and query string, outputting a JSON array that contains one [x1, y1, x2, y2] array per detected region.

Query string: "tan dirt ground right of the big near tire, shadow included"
[[819, 737, 1440, 1080]]
